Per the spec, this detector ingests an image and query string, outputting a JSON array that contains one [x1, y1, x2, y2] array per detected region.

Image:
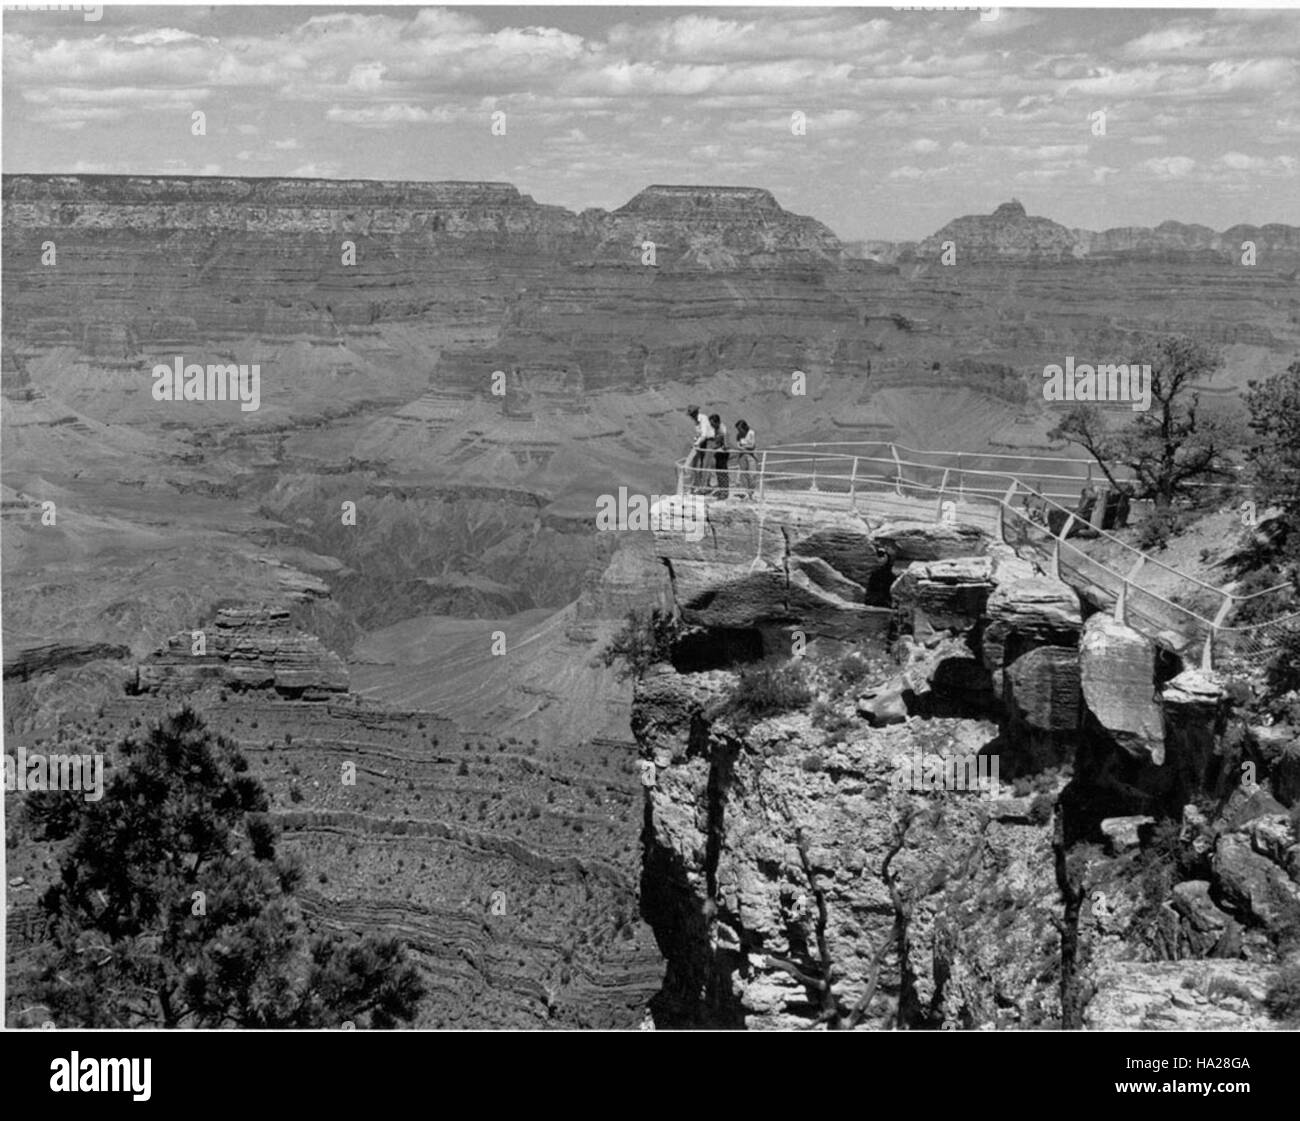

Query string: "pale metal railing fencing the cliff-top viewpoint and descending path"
[[677, 442, 1300, 668]]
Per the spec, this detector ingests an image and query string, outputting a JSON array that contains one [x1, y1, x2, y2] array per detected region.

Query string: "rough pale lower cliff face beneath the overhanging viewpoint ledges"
[[634, 672, 1058, 1029]]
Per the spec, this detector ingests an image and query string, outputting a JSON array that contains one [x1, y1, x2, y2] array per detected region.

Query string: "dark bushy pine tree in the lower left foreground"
[[16, 707, 424, 1027]]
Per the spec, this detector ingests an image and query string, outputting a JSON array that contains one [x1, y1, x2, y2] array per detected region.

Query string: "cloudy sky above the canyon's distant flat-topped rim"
[[3, 7, 1300, 238]]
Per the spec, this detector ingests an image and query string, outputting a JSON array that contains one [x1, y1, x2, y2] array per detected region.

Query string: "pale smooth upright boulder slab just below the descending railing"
[[1079, 614, 1165, 766]]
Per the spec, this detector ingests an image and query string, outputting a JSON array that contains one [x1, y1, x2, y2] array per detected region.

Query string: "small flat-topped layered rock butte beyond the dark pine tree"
[[134, 607, 348, 700]]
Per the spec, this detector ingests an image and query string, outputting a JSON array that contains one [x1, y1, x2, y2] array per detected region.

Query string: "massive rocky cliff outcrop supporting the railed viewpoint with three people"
[[632, 503, 1300, 1029]]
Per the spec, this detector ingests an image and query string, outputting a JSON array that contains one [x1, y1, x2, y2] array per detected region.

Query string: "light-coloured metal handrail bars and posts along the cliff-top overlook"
[[677, 441, 1300, 666]]
